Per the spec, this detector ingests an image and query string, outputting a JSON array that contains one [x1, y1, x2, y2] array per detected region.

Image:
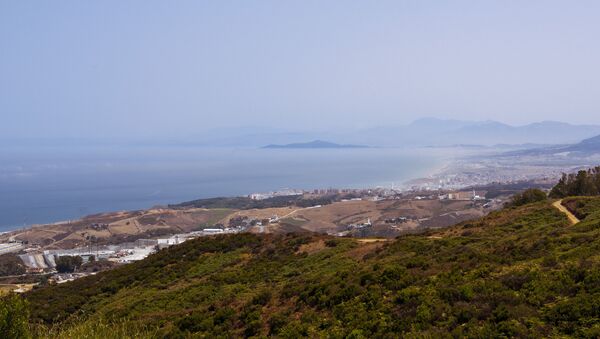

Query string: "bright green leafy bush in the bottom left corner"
[[0, 294, 31, 339]]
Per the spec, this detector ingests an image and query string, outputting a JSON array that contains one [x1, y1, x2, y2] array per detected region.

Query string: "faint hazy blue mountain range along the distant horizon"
[[180, 118, 600, 147]]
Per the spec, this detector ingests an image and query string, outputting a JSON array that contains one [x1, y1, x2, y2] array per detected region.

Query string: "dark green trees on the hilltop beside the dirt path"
[[550, 166, 600, 198]]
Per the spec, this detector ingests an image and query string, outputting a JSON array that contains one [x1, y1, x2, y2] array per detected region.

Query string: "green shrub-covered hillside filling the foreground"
[[19, 198, 600, 338]]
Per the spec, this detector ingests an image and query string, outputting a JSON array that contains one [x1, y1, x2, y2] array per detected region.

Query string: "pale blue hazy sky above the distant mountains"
[[0, 0, 600, 137]]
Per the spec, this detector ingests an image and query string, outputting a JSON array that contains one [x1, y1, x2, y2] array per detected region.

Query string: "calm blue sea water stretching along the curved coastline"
[[0, 147, 448, 231]]
